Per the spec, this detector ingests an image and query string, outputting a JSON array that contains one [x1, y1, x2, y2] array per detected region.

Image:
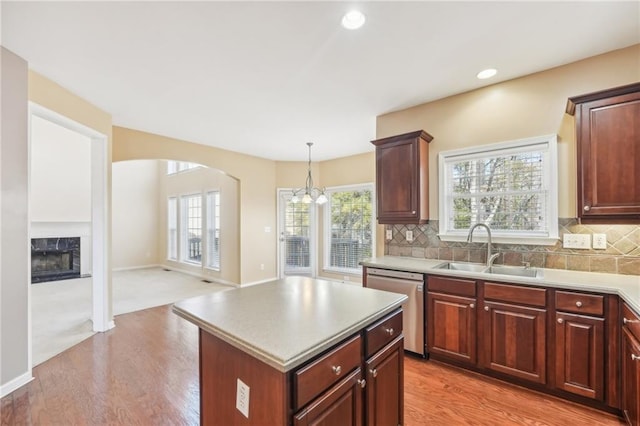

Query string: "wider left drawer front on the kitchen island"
[[294, 335, 362, 410]]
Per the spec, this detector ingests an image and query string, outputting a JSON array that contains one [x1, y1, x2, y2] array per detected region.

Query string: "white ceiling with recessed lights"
[[1, 1, 640, 161]]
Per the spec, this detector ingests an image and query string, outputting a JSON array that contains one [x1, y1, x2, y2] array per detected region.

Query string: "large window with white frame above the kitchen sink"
[[439, 135, 558, 244]]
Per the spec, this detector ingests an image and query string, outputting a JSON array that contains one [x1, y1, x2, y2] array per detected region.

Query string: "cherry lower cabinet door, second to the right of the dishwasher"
[[483, 302, 546, 383]]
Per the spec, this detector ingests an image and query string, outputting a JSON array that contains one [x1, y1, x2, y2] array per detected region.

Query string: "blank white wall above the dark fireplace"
[[30, 116, 91, 222]]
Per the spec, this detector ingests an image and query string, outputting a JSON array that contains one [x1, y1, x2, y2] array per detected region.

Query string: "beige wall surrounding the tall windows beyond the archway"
[[156, 161, 240, 284]]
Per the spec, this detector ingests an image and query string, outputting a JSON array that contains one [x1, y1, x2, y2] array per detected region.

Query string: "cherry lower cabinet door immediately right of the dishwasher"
[[427, 293, 477, 365]]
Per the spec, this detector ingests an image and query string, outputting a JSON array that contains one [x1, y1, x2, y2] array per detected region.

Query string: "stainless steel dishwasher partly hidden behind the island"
[[367, 268, 426, 357]]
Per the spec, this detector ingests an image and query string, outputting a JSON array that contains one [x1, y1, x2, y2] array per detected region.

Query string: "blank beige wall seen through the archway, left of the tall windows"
[[111, 160, 163, 270]]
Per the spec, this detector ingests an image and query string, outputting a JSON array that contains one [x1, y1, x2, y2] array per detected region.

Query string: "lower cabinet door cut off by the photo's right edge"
[[622, 327, 640, 426]]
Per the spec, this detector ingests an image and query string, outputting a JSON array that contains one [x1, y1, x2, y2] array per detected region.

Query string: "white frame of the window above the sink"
[[438, 134, 559, 245]]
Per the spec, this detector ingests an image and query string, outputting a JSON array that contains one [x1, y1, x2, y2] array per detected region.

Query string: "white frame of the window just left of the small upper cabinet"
[[322, 183, 377, 276]]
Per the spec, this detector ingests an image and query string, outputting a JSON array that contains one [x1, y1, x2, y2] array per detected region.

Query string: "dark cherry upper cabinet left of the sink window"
[[371, 130, 433, 224]]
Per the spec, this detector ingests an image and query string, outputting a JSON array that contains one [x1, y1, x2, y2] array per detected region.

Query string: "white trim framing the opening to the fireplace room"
[[27, 102, 115, 364]]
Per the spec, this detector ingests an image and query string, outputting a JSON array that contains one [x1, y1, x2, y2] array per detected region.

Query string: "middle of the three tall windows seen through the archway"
[[180, 194, 202, 264]]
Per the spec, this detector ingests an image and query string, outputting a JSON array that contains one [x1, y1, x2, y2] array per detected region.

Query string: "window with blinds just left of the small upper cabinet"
[[324, 185, 375, 274]]
